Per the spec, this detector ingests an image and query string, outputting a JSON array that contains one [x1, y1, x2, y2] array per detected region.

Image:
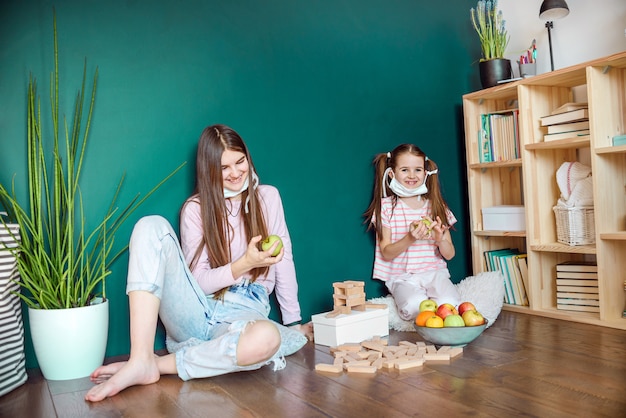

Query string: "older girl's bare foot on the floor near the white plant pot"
[[85, 357, 161, 402]]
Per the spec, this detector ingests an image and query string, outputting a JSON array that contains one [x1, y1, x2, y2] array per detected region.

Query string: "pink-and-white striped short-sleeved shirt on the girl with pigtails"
[[373, 197, 457, 281]]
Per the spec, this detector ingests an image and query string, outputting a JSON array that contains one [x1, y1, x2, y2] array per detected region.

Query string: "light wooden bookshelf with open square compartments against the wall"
[[463, 52, 626, 330]]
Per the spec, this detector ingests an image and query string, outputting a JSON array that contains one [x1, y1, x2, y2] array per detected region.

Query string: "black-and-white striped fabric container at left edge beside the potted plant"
[[0, 223, 27, 396]]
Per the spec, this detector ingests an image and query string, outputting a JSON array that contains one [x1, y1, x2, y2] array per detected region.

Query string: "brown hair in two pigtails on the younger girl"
[[363, 144, 449, 239]]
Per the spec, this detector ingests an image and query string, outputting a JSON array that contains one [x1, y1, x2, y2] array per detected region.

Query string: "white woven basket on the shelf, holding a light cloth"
[[552, 206, 596, 245]]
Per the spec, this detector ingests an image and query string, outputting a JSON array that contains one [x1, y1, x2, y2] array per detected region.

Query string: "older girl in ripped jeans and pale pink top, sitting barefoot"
[[85, 125, 312, 401]]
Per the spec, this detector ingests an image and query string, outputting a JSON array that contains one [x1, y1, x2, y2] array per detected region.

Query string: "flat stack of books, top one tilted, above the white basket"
[[541, 103, 589, 142]]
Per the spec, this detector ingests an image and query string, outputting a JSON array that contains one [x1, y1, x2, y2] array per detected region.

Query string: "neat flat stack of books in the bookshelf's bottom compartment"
[[556, 261, 600, 312]]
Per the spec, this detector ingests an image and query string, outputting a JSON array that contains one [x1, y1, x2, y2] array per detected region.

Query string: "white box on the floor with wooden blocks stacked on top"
[[311, 308, 389, 347]]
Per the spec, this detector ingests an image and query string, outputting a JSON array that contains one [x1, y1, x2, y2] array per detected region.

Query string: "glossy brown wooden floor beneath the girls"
[[0, 311, 626, 418]]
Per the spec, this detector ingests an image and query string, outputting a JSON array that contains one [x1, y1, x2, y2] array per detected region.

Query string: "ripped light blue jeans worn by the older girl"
[[126, 216, 307, 380]]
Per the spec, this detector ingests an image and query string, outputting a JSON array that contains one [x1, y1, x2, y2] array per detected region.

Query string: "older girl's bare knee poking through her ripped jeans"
[[237, 321, 281, 366]]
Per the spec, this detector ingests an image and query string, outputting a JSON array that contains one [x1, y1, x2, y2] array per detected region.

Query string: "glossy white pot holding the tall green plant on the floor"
[[28, 298, 109, 380]]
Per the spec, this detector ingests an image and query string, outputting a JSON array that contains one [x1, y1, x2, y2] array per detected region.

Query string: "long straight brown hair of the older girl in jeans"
[[183, 125, 269, 299]]
